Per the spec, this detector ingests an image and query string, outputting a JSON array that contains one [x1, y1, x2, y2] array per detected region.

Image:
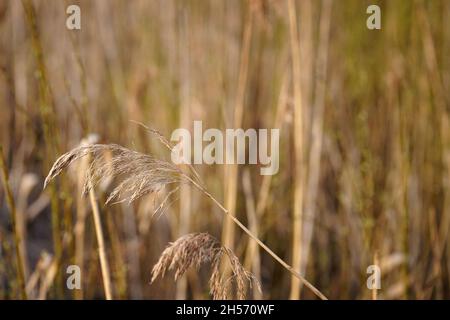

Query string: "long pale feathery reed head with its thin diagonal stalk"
[[44, 132, 327, 300]]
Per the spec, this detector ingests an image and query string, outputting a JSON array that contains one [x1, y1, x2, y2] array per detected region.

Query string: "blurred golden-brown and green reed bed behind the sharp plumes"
[[0, 0, 450, 299]]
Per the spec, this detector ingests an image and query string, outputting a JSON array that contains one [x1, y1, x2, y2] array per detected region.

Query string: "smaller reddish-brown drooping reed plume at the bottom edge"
[[151, 233, 261, 300]]
